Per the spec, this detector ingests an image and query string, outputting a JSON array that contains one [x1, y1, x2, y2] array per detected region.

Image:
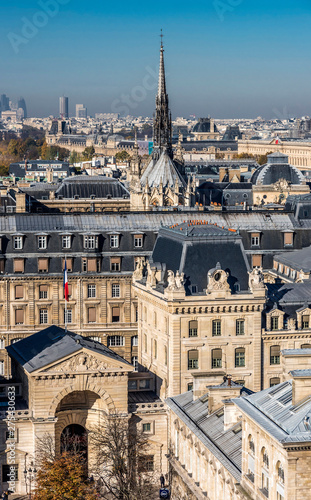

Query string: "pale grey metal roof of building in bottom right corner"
[[233, 378, 311, 444]]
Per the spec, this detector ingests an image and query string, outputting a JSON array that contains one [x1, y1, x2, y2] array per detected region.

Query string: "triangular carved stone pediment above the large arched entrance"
[[32, 349, 134, 375]]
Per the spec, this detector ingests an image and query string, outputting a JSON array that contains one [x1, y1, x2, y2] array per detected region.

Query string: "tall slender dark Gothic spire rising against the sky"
[[153, 30, 172, 156]]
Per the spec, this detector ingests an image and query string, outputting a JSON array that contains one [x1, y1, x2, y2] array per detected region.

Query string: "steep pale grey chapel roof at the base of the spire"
[[140, 151, 186, 188]]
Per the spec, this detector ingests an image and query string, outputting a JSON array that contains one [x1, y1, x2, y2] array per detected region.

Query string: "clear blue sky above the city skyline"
[[0, 0, 311, 118]]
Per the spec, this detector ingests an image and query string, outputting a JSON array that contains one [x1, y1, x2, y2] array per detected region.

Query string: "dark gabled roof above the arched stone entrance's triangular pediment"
[[6, 325, 131, 373]]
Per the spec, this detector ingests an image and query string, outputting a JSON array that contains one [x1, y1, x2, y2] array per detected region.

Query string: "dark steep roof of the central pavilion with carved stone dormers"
[[152, 221, 249, 295]]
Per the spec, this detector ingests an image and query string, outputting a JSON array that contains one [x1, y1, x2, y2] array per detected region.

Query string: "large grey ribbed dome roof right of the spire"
[[251, 153, 306, 186]]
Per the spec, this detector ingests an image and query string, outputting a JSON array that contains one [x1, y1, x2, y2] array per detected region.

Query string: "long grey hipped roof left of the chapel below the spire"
[[56, 175, 130, 199]]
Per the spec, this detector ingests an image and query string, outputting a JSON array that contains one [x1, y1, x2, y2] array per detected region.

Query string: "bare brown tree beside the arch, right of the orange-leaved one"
[[89, 413, 156, 500]]
